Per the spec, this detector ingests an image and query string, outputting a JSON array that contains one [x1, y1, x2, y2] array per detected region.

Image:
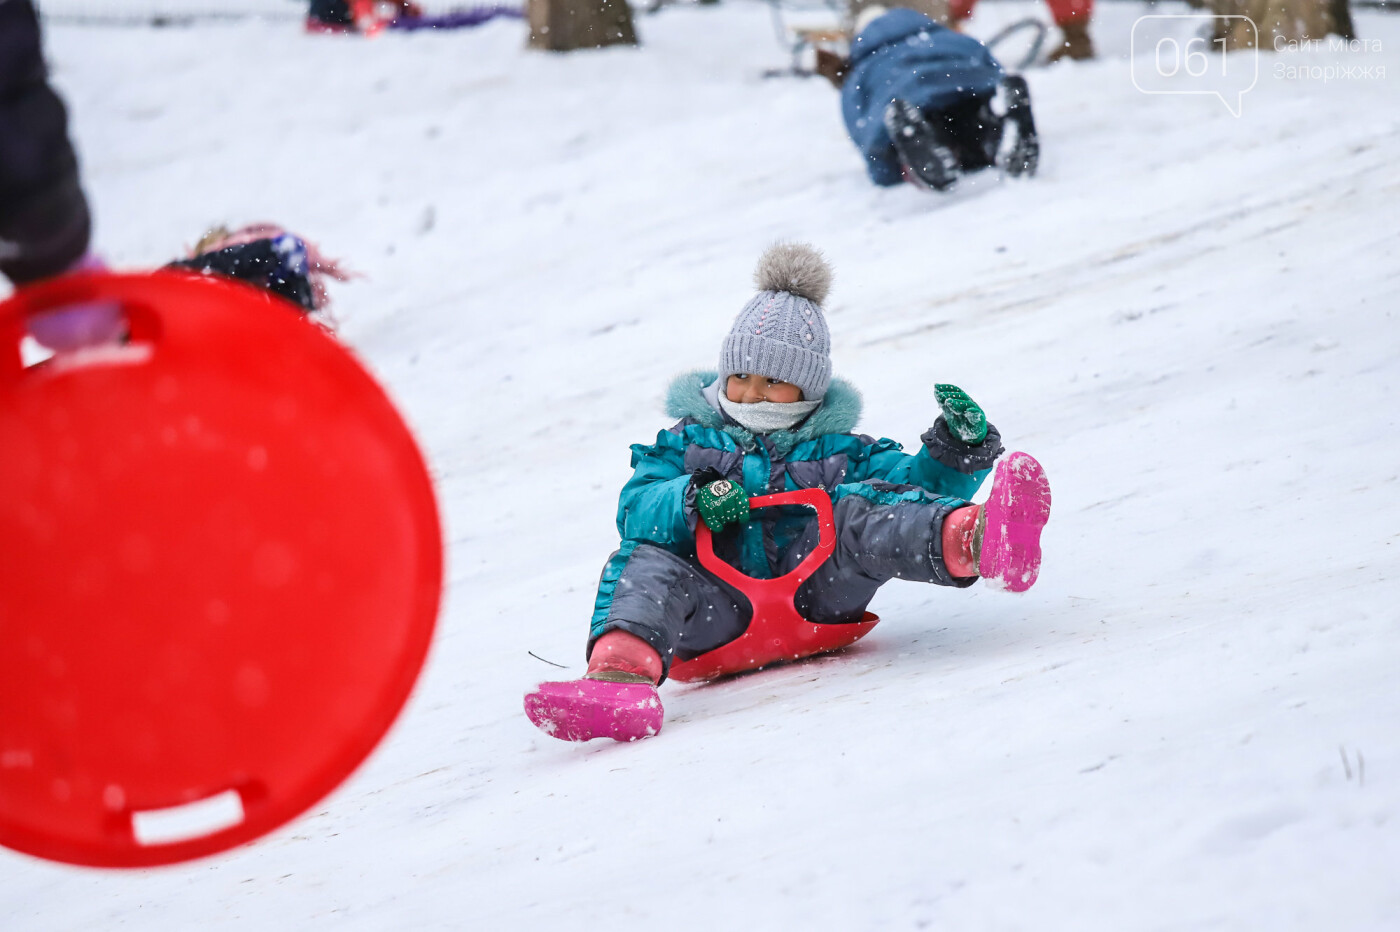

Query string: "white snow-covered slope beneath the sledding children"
[[0, 3, 1400, 932]]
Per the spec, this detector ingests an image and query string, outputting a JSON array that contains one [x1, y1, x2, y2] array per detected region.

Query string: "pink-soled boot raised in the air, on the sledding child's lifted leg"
[[977, 453, 1050, 592]]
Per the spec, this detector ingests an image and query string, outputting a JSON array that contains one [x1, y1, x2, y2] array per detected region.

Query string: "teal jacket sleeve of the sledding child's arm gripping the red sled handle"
[[617, 431, 694, 553]]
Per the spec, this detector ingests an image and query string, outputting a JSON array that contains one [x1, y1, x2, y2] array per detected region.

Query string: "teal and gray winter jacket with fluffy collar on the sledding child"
[[601, 372, 1002, 582]]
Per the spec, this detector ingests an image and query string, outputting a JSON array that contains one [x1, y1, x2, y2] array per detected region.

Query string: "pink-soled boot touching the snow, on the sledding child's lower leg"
[[525, 677, 662, 742]]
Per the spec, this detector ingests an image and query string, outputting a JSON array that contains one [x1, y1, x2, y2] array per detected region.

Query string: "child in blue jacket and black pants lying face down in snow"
[[816, 7, 1040, 190]]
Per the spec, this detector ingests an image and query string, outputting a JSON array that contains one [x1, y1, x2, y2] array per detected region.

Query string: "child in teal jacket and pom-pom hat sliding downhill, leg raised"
[[525, 245, 1050, 740]]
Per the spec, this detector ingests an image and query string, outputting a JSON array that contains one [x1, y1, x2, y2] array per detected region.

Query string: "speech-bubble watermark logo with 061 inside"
[[1130, 13, 1259, 116]]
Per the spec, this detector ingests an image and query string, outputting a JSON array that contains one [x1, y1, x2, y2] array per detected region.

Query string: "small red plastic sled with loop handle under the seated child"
[[671, 488, 879, 683]]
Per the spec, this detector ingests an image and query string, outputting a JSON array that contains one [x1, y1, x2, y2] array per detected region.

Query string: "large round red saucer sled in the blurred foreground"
[[0, 273, 442, 868]]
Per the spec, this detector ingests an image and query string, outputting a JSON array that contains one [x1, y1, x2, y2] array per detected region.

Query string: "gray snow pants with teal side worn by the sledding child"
[[588, 495, 976, 680]]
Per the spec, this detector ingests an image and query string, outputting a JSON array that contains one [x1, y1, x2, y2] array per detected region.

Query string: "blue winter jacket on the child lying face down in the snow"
[[841, 8, 1001, 185]]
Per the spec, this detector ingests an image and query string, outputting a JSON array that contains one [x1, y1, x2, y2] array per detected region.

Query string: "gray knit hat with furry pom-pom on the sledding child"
[[720, 242, 832, 402]]
